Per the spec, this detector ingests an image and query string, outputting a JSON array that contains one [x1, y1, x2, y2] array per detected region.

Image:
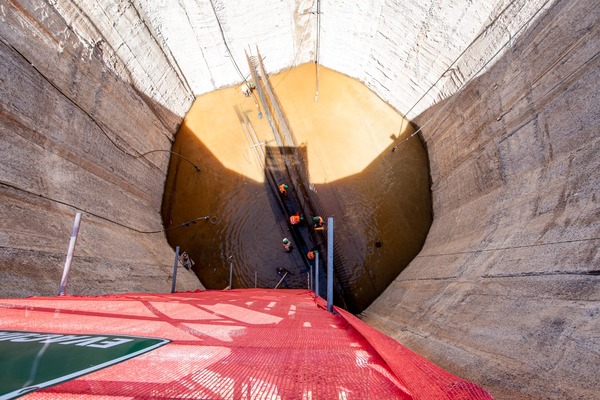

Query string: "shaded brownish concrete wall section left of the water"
[[0, 2, 201, 297]]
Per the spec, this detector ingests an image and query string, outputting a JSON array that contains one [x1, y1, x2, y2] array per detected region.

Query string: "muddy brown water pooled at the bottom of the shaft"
[[163, 64, 432, 312]]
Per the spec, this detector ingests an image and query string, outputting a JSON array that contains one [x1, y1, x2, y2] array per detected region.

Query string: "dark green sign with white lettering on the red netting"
[[0, 331, 169, 400]]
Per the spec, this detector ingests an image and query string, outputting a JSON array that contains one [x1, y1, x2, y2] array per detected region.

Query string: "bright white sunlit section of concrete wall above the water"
[[27, 0, 554, 117]]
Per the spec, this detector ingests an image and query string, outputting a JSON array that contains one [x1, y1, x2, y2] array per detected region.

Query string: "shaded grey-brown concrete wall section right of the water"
[[364, 1, 600, 399]]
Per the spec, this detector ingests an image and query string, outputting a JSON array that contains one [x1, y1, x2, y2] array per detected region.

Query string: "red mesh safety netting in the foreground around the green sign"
[[0, 289, 491, 399]]
